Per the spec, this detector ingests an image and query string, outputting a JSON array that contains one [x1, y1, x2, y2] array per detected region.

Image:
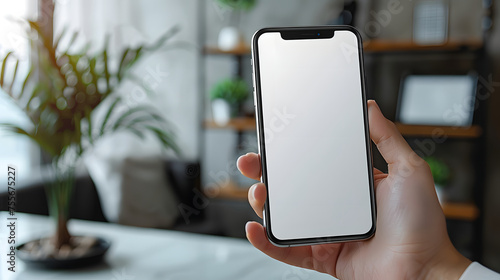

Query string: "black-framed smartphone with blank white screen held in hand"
[[252, 26, 376, 246]]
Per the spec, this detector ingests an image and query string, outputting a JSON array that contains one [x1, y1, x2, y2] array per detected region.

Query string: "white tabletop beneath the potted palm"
[[0, 212, 333, 280]]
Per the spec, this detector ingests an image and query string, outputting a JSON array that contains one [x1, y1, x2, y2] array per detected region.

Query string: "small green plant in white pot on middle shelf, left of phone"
[[210, 79, 248, 125]]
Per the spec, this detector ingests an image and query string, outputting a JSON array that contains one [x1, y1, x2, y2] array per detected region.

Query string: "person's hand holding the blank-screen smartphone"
[[237, 100, 470, 280]]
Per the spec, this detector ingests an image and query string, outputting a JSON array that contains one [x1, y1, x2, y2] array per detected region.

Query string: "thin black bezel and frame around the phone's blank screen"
[[252, 26, 376, 247]]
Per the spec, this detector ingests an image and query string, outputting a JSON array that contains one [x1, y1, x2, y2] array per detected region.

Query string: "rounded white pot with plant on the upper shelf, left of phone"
[[216, 0, 257, 51]]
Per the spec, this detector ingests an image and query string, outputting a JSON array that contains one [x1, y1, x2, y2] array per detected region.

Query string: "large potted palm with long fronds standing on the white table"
[[0, 17, 177, 266]]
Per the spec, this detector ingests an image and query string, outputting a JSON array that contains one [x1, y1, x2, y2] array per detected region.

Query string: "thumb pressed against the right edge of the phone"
[[368, 100, 416, 166]]
